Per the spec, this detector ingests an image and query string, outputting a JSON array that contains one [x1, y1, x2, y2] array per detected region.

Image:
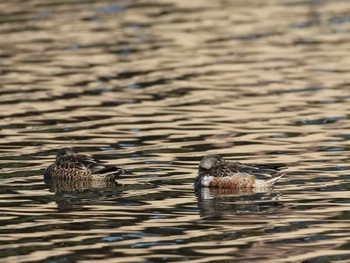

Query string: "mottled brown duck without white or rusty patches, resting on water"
[[44, 147, 124, 181]]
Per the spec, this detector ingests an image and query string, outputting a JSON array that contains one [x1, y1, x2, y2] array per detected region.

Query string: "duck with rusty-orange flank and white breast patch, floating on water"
[[194, 154, 286, 190]]
